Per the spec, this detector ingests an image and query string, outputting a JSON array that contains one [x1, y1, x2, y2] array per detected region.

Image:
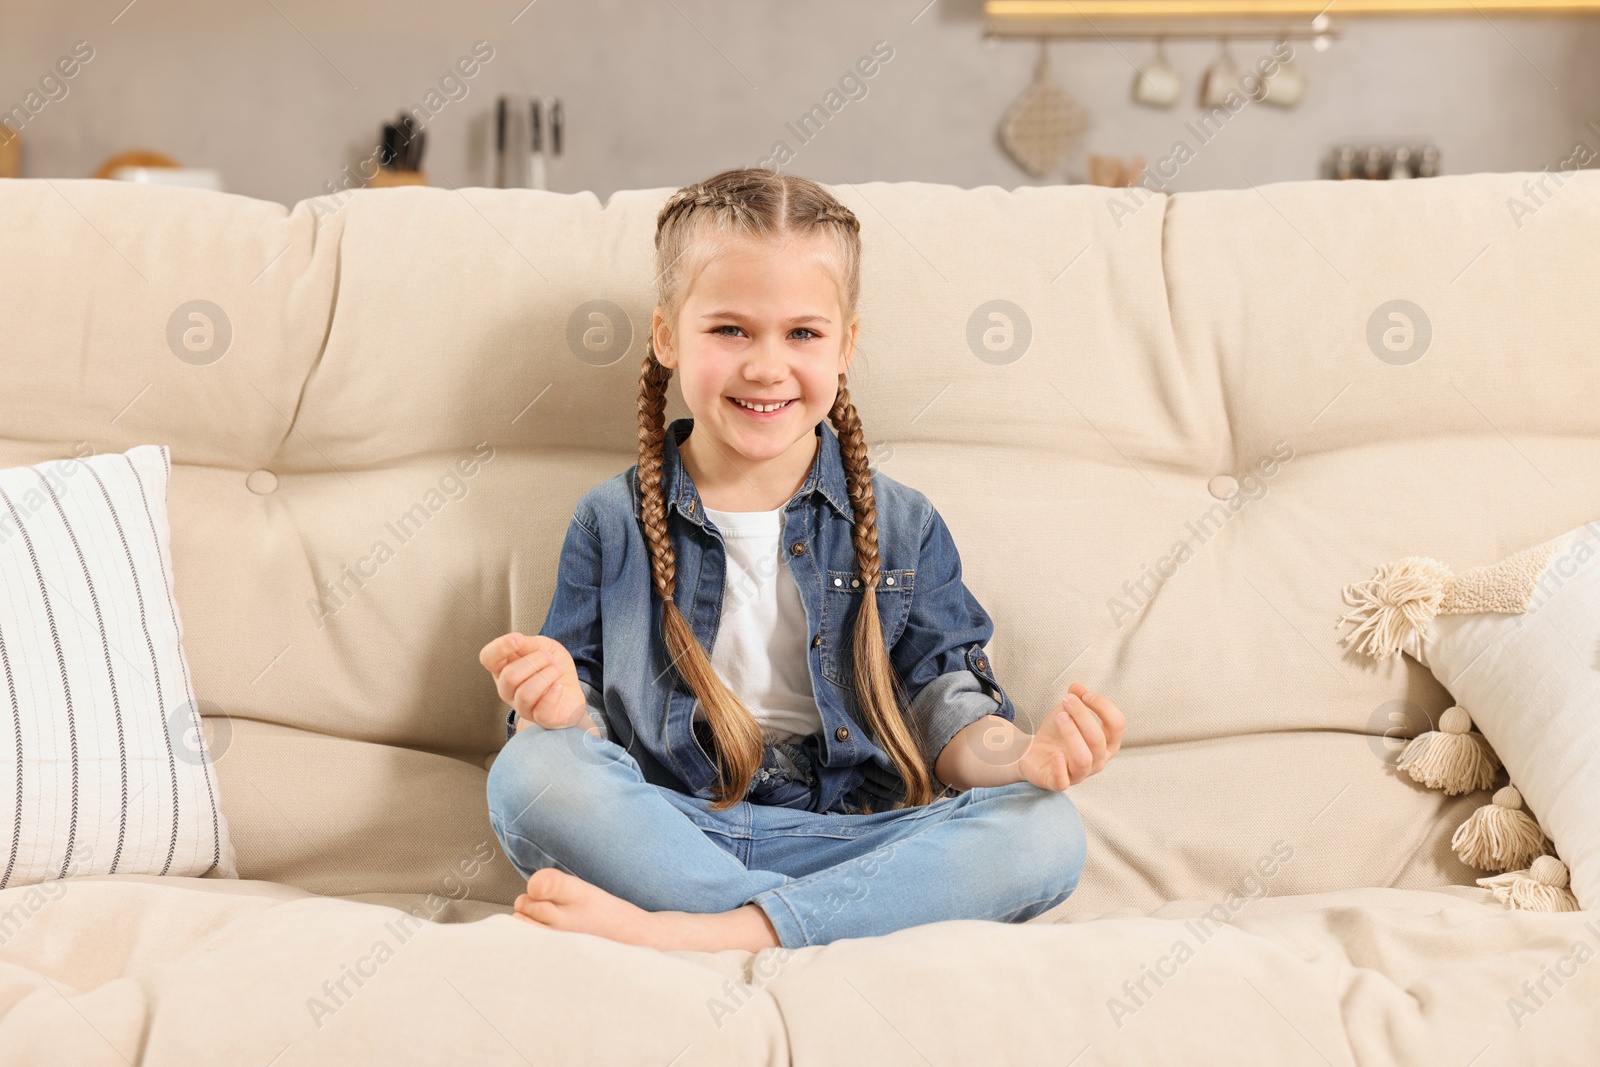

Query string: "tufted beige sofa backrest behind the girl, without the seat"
[[0, 173, 1600, 910]]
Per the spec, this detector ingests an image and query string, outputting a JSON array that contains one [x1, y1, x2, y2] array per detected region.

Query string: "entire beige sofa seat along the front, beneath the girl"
[[0, 875, 1600, 1067]]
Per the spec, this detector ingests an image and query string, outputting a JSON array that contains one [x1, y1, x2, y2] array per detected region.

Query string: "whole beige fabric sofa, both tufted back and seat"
[[0, 173, 1600, 1067]]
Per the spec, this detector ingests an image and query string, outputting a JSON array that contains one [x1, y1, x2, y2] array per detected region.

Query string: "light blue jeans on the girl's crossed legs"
[[488, 723, 1086, 949]]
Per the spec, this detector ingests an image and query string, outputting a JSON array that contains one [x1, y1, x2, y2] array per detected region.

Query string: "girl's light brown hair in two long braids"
[[638, 166, 933, 813]]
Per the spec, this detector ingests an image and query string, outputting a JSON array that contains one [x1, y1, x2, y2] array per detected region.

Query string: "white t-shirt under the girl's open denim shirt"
[[694, 507, 822, 742]]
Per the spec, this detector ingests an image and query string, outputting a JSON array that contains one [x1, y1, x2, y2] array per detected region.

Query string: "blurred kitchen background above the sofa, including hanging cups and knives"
[[0, 0, 1600, 205]]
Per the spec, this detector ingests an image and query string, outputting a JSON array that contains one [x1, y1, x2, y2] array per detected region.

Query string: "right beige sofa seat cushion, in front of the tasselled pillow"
[[765, 886, 1600, 1067]]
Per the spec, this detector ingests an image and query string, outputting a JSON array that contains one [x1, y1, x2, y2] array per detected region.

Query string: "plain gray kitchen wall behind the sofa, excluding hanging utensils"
[[0, 0, 1600, 203]]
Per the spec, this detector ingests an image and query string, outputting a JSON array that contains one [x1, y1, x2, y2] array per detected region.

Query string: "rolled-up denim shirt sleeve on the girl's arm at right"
[[890, 504, 1016, 787]]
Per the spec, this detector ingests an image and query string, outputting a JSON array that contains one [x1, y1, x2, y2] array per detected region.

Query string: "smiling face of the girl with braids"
[[651, 237, 859, 469]]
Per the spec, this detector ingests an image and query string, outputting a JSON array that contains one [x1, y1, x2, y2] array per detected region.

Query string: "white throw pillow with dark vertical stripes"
[[0, 445, 238, 889]]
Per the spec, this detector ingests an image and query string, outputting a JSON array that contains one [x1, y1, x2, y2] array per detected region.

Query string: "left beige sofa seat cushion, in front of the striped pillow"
[[0, 875, 789, 1067]]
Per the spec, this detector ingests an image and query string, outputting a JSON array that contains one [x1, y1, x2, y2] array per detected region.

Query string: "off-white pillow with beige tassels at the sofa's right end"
[[1336, 522, 1600, 910]]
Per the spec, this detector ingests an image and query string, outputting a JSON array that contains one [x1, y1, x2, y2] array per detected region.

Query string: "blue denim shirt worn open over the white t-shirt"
[[506, 418, 1016, 813]]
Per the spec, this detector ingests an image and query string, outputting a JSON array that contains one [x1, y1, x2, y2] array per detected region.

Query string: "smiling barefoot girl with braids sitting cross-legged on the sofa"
[[478, 168, 1125, 952]]
